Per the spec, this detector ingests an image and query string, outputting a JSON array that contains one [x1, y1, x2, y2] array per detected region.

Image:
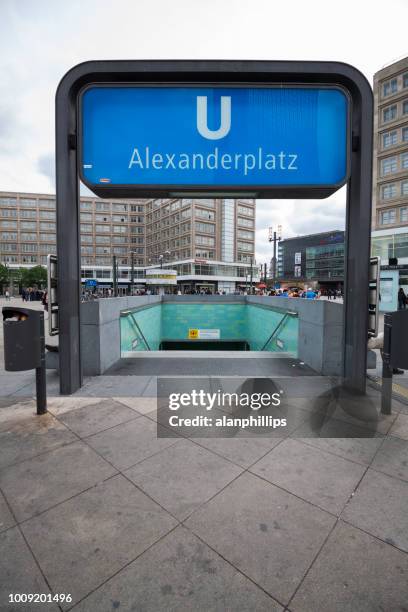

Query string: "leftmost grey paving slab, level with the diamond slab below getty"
[[0, 442, 117, 521]]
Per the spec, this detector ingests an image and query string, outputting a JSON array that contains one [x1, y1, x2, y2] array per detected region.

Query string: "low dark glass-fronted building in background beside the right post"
[[277, 230, 344, 289]]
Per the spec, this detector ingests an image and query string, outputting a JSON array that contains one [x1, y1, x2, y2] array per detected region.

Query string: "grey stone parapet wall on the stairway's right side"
[[247, 296, 343, 376]]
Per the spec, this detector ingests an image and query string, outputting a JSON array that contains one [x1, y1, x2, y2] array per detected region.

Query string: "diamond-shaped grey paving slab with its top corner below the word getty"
[[126, 440, 242, 521]]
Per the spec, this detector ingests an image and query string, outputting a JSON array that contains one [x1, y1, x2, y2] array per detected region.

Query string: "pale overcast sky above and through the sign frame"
[[0, 0, 408, 263]]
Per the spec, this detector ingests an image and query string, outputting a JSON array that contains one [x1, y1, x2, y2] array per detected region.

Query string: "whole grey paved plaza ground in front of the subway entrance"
[[0, 392, 408, 612]]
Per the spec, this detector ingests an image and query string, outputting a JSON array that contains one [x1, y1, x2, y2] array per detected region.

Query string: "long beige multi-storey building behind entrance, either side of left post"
[[0, 192, 257, 293]]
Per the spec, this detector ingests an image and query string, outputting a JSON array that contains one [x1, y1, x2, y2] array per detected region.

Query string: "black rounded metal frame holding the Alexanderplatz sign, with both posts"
[[56, 60, 373, 394]]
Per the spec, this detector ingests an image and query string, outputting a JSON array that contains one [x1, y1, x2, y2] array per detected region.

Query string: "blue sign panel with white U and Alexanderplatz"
[[79, 85, 350, 194]]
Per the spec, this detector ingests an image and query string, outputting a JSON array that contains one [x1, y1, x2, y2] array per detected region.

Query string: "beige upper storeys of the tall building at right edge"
[[372, 57, 408, 230]]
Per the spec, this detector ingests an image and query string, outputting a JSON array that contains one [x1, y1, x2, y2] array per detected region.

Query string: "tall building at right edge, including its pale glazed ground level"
[[371, 57, 408, 310]]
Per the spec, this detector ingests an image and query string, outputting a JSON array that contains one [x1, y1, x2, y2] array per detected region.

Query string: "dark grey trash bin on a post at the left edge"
[[3, 306, 47, 414]]
